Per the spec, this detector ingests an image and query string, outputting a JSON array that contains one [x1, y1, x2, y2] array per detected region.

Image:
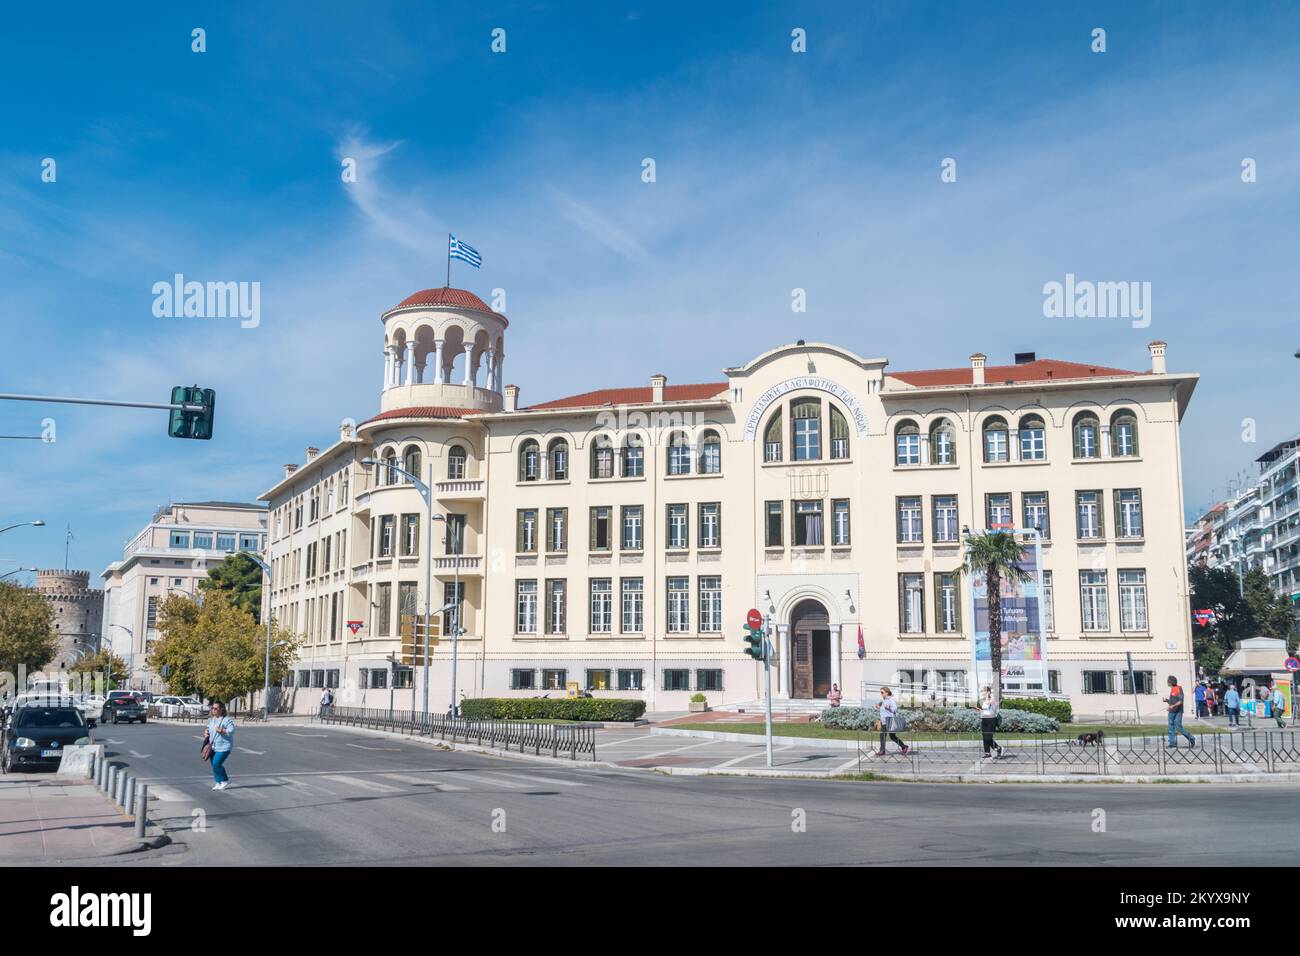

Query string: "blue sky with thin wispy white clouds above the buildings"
[[0, 0, 1300, 576]]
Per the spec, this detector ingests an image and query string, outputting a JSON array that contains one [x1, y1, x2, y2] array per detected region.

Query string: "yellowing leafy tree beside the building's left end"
[[150, 589, 302, 701]]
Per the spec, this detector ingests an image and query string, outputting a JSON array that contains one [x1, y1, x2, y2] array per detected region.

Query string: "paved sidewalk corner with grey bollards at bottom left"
[[0, 774, 168, 865]]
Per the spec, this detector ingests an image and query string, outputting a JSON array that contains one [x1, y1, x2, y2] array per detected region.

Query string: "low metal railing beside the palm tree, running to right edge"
[[858, 730, 1300, 777]]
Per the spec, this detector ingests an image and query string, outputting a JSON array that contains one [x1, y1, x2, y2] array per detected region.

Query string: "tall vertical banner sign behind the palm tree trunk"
[[971, 531, 1048, 695]]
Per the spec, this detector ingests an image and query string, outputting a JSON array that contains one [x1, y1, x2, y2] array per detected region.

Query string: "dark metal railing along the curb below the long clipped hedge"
[[312, 706, 595, 760]]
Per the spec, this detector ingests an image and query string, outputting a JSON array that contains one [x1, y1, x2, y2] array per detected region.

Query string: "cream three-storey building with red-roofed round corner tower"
[[261, 287, 1197, 714]]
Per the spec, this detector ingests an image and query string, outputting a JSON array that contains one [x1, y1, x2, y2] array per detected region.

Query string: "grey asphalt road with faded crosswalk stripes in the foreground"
[[68, 723, 1300, 866]]
